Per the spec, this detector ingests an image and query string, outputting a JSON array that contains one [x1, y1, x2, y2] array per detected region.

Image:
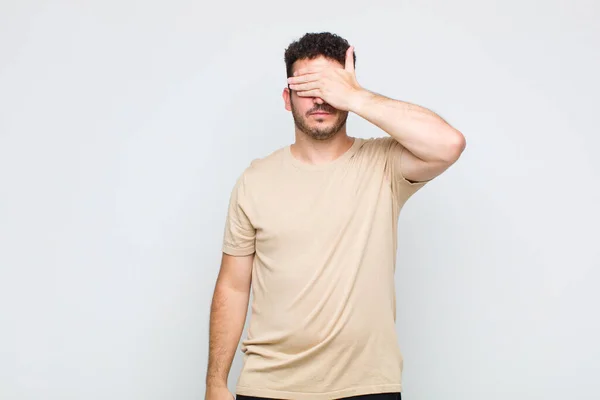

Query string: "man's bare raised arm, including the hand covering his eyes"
[[288, 46, 466, 181]]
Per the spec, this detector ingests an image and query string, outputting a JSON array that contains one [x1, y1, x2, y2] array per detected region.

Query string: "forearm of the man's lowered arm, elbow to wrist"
[[206, 283, 250, 386]]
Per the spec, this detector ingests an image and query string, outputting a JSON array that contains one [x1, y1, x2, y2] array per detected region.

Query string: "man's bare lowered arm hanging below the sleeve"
[[205, 253, 254, 400]]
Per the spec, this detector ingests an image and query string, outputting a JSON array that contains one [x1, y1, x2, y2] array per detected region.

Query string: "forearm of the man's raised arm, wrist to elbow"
[[350, 89, 464, 161]]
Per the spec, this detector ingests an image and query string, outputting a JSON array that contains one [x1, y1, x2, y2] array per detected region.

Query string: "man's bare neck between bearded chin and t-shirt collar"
[[290, 132, 355, 165]]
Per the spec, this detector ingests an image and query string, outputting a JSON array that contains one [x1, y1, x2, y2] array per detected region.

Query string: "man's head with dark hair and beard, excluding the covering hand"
[[283, 32, 356, 140]]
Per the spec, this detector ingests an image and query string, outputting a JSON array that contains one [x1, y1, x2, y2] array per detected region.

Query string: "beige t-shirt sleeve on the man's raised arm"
[[378, 136, 431, 204]]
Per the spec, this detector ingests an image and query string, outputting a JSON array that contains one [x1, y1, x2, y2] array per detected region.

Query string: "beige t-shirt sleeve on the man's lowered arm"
[[222, 175, 256, 256]]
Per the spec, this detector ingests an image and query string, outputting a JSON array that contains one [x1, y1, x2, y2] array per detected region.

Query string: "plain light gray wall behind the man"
[[0, 0, 600, 400]]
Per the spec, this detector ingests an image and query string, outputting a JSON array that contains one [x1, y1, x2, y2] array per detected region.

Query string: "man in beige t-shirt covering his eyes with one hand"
[[206, 33, 465, 400]]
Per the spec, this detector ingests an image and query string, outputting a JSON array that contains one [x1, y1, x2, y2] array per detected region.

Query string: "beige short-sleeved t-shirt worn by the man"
[[223, 137, 425, 400]]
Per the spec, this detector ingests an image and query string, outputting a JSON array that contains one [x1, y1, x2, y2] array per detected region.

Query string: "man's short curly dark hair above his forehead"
[[284, 32, 356, 78]]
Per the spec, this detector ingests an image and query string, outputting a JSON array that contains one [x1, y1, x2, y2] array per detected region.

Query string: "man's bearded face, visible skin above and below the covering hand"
[[283, 57, 348, 140]]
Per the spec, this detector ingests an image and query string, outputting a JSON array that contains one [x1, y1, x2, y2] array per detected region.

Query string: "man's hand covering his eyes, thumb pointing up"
[[288, 46, 365, 111]]
